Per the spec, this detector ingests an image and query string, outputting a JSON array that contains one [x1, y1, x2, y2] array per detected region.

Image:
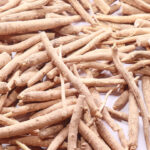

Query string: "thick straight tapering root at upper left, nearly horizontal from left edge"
[[0, 16, 81, 35]]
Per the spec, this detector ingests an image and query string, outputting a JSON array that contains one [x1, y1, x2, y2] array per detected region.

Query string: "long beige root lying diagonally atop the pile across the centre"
[[41, 32, 100, 116]]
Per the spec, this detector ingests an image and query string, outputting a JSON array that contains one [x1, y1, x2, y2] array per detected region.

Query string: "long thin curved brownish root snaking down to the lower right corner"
[[113, 47, 150, 149]]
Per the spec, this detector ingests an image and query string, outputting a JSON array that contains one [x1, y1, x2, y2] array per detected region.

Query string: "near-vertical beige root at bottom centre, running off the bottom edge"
[[67, 95, 85, 150]]
